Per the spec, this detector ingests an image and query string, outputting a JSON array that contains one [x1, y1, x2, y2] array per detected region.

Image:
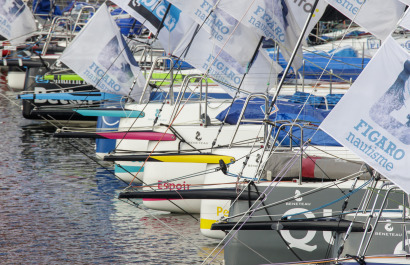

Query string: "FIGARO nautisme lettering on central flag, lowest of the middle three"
[[203, 54, 241, 85]]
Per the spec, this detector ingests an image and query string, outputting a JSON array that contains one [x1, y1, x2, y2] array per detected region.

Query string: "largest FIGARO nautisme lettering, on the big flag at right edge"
[[346, 119, 406, 171]]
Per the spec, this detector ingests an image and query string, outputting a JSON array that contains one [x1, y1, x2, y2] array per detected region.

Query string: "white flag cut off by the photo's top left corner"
[[0, 0, 37, 45]]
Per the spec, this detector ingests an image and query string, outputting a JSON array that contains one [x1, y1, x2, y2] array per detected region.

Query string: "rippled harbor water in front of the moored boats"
[[0, 76, 223, 264]]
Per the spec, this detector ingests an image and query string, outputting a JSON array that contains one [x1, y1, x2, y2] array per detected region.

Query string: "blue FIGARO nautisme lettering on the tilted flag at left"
[[84, 62, 121, 92]]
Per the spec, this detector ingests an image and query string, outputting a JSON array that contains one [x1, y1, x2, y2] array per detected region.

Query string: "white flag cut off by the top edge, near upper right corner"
[[326, 0, 406, 40]]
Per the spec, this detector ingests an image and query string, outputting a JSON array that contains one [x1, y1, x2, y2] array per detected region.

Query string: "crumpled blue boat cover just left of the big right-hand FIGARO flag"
[[216, 96, 340, 146]]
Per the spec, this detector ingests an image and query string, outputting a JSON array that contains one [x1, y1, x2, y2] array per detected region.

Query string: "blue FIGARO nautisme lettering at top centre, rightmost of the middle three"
[[248, 6, 285, 43]]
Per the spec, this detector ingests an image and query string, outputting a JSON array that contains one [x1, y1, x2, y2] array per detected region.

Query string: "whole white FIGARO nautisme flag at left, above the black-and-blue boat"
[[60, 4, 145, 100]]
